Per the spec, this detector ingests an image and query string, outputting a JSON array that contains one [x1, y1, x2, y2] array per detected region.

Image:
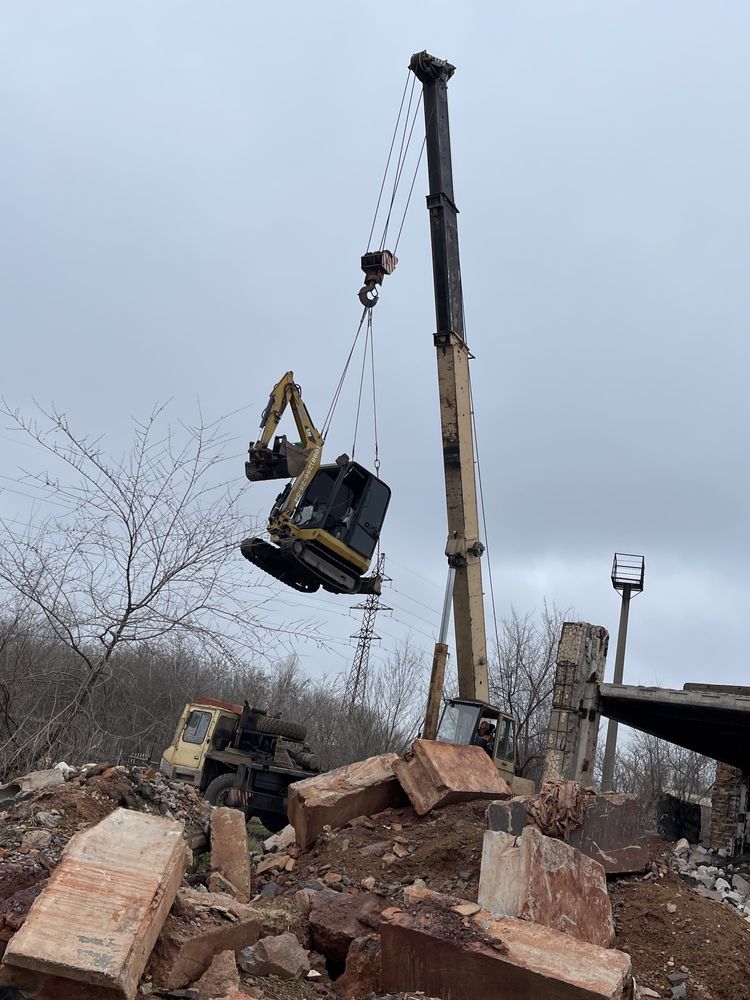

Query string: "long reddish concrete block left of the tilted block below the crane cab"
[[287, 753, 406, 850]]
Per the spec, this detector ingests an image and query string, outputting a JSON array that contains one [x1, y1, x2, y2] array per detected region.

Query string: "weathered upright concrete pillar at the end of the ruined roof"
[[543, 622, 609, 787]]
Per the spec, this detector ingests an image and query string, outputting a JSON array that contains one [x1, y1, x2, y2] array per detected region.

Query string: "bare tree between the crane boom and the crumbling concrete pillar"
[[490, 602, 571, 782]]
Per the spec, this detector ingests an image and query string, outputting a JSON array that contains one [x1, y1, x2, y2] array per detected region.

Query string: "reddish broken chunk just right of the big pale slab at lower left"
[[146, 889, 261, 990]]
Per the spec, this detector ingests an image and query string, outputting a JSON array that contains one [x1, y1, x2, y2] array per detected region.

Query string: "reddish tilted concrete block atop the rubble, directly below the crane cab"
[[393, 740, 510, 816]]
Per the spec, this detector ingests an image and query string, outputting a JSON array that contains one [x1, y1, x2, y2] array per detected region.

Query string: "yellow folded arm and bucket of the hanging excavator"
[[245, 372, 324, 486]]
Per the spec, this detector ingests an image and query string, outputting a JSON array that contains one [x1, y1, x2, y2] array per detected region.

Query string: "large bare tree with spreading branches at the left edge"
[[0, 406, 305, 766]]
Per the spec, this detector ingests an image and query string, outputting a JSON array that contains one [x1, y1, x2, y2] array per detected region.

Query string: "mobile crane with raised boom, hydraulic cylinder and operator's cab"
[[409, 52, 522, 780]]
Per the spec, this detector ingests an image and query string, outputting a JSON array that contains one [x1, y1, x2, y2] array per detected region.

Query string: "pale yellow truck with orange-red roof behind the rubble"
[[159, 697, 320, 832]]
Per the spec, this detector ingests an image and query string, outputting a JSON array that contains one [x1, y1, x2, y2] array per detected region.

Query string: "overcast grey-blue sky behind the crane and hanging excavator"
[[0, 0, 750, 686]]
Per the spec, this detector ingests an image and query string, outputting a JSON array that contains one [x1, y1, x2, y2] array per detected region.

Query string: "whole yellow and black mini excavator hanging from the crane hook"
[[240, 372, 391, 594]]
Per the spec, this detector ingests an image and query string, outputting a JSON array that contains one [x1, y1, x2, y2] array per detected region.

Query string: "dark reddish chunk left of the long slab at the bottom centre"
[[310, 889, 388, 972]]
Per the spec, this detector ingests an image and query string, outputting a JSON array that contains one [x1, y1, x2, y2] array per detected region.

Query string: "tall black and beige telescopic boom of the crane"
[[409, 52, 489, 701]]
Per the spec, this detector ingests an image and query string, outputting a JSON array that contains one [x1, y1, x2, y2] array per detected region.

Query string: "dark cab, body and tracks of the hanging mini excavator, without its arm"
[[241, 460, 391, 594]]
